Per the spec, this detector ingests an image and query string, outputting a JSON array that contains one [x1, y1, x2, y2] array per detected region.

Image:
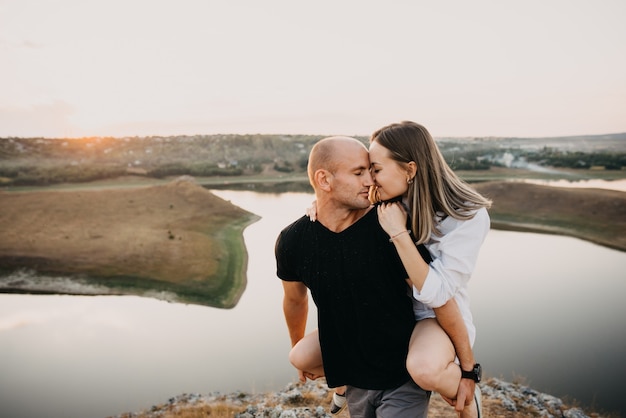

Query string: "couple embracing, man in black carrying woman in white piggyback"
[[275, 122, 491, 418]]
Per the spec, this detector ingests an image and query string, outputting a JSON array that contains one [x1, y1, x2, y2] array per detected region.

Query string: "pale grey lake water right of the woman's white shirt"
[[470, 230, 626, 413]]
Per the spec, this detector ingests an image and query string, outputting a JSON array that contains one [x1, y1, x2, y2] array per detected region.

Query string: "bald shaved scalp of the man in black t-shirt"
[[307, 136, 367, 188]]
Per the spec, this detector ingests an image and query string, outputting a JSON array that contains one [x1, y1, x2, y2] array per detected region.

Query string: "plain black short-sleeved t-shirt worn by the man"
[[275, 210, 415, 389]]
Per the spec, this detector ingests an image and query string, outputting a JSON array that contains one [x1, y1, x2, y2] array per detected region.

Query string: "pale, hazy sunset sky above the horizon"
[[0, 0, 626, 138]]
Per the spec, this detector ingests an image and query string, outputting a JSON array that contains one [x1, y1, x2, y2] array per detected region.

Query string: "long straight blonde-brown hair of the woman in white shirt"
[[370, 121, 491, 244]]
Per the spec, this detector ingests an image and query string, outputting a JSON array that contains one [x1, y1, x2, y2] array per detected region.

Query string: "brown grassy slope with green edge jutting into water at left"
[[0, 181, 258, 308]]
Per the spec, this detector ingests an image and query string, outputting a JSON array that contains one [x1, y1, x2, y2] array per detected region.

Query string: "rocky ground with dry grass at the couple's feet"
[[109, 379, 606, 418]]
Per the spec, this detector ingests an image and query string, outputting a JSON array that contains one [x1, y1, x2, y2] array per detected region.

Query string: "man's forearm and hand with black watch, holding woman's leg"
[[434, 298, 475, 411]]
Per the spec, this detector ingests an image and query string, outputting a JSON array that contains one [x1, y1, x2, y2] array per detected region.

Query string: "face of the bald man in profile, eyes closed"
[[329, 144, 373, 209]]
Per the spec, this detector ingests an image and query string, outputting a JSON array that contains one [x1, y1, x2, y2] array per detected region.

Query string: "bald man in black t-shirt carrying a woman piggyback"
[[276, 137, 430, 418]]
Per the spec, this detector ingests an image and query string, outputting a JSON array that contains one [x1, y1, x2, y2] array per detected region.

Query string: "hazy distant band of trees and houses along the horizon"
[[0, 133, 626, 185]]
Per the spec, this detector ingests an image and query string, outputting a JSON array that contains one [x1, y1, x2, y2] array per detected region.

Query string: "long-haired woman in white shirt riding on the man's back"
[[290, 122, 491, 417]]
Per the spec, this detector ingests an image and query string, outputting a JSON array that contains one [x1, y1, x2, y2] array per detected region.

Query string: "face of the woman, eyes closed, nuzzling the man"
[[370, 142, 409, 200]]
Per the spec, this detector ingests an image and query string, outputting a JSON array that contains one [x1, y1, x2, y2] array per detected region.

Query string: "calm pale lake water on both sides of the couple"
[[0, 184, 626, 418]]
